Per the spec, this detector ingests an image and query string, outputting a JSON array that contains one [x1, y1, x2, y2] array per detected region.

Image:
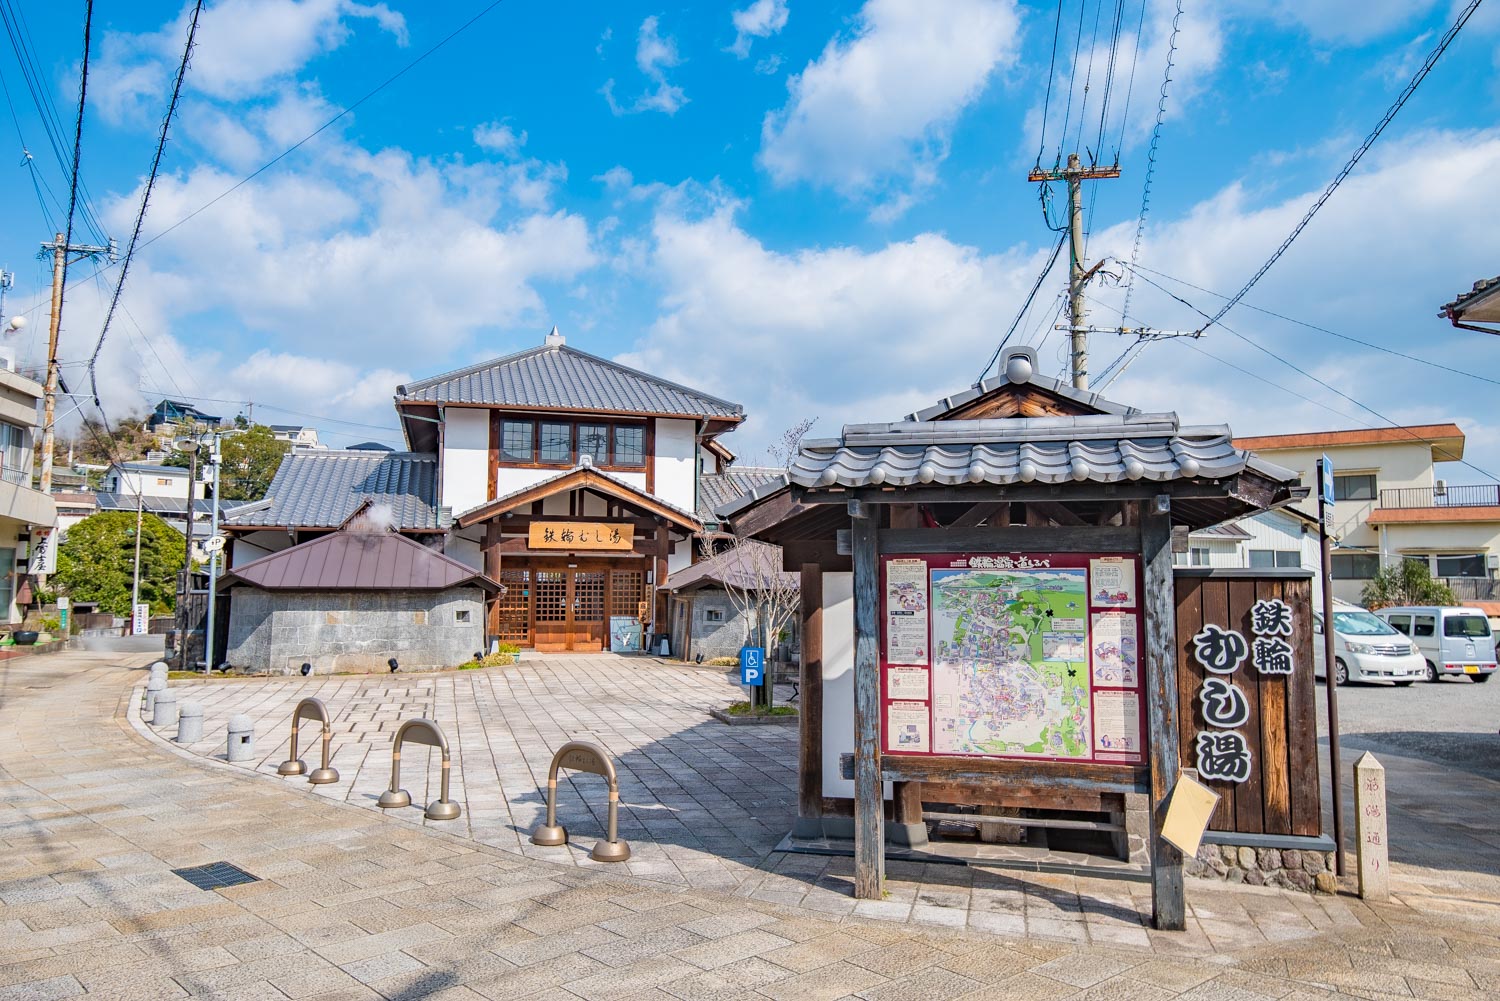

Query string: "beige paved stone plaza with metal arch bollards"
[[0, 654, 1500, 1001]]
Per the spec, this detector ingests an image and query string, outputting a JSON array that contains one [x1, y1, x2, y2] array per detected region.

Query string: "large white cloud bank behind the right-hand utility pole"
[[627, 129, 1500, 480]]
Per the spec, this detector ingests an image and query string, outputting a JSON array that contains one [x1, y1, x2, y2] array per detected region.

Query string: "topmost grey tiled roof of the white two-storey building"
[[396, 336, 744, 420]]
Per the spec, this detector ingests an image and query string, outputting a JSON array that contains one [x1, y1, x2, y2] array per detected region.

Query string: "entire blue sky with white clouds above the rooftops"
[[0, 0, 1500, 480]]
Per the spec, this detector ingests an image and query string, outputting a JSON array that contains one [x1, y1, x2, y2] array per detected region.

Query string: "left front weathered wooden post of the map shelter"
[[849, 501, 885, 900]]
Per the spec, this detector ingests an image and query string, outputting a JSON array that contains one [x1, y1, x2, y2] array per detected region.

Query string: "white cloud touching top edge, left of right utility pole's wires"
[[759, 0, 1020, 215]]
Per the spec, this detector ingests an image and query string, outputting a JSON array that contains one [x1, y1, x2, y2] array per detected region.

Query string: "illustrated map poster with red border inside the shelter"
[[881, 554, 1145, 764]]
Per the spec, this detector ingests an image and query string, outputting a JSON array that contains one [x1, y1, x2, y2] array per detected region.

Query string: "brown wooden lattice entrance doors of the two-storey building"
[[498, 561, 647, 653]]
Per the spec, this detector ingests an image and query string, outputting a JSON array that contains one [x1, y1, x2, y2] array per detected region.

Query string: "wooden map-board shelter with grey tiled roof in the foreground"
[[719, 348, 1316, 929]]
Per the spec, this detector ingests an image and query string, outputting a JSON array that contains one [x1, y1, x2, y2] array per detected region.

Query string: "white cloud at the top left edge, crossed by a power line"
[[92, 0, 407, 122]]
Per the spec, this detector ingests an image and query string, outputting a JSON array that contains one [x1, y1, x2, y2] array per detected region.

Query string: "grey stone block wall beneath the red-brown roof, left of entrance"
[[227, 587, 485, 674]]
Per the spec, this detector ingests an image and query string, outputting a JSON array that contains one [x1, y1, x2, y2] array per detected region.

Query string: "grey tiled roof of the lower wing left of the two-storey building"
[[224, 449, 446, 531]]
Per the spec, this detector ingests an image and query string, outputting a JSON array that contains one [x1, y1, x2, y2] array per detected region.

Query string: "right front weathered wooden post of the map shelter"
[[1140, 501, 1187, 932]]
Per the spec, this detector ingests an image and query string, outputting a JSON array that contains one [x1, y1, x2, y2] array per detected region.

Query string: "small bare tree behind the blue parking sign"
[[701, 536, 803, 708]]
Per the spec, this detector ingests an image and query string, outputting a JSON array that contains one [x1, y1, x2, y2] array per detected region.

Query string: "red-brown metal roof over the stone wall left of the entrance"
[[224, 531, 506, 591]]
